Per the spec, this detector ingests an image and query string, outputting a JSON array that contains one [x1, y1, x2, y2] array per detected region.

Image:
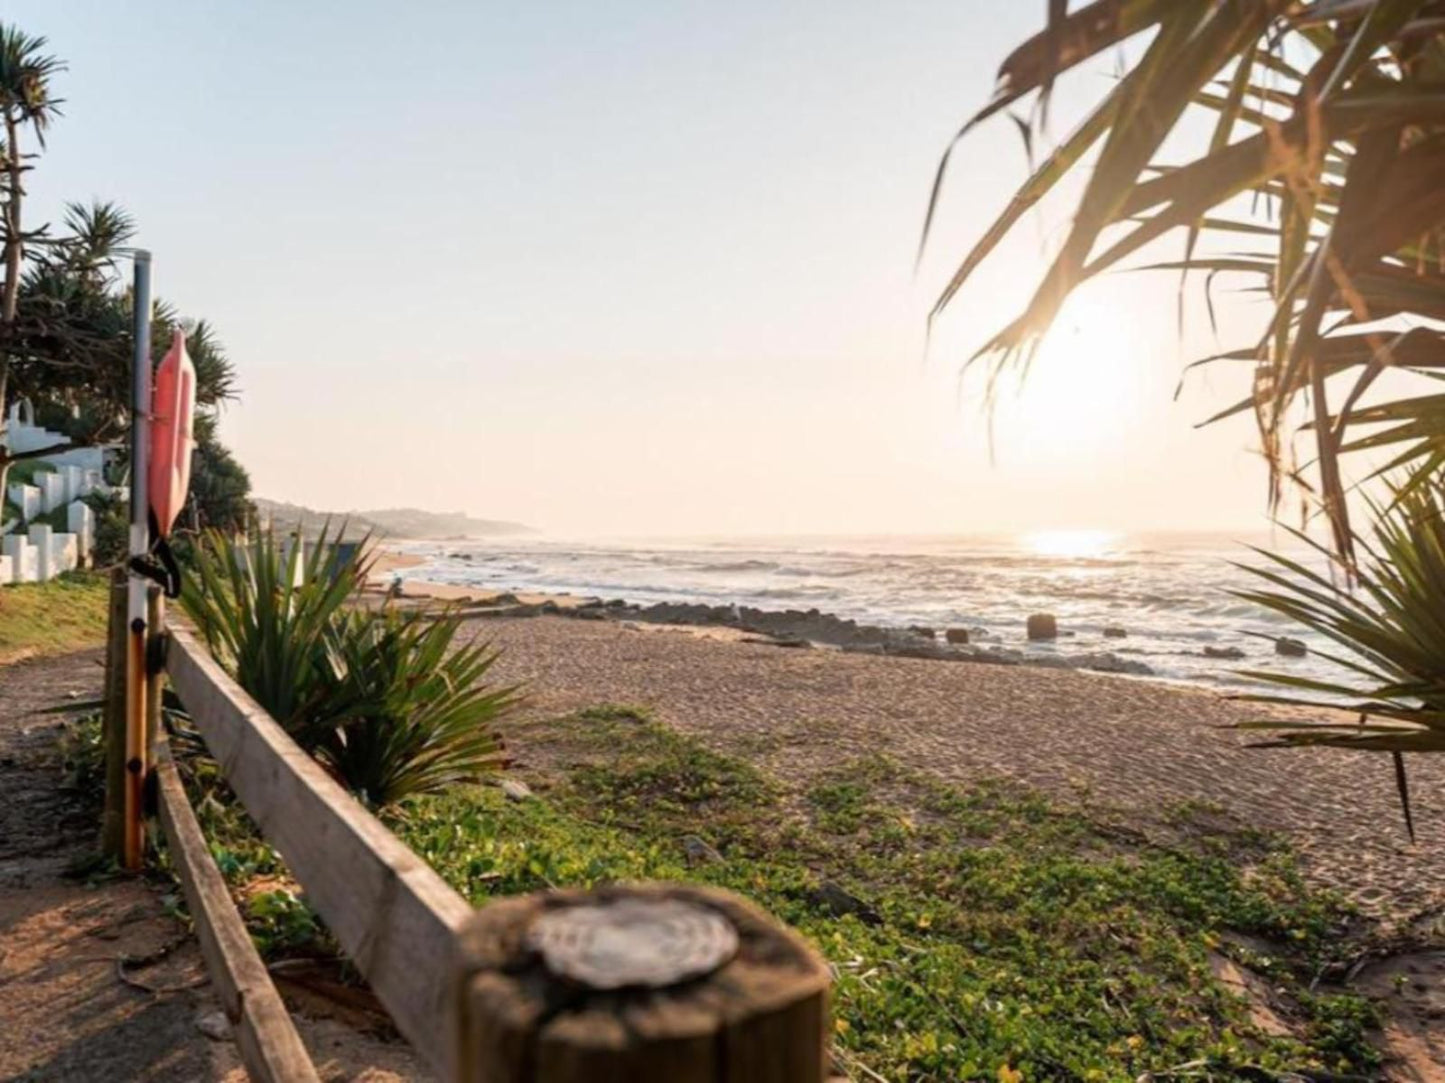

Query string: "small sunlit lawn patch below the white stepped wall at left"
[[0, 573, 108, 665]]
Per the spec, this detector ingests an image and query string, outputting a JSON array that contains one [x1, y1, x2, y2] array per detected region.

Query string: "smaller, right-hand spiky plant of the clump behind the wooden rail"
[[315, 610, 516, 807]]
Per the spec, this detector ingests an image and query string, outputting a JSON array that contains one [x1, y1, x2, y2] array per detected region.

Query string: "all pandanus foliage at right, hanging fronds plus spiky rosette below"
[[923, 0, 1445, 809]]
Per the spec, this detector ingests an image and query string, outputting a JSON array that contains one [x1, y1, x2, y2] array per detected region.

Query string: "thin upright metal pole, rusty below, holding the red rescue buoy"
[[123, 249, 150, 869]]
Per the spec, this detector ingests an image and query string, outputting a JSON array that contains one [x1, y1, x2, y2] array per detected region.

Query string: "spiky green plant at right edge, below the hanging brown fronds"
[[1237, 476, 1445, 837]]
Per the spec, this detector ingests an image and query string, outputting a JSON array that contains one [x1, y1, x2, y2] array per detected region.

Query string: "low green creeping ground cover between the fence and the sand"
[[390, 707, 1377, 1080]]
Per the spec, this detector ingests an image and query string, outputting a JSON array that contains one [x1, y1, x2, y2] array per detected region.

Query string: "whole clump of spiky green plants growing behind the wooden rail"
[[182, 531, 514, 807]]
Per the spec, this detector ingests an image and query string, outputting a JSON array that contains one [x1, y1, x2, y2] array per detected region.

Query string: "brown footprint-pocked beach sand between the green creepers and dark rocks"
[[474, 617, 1445, 917]]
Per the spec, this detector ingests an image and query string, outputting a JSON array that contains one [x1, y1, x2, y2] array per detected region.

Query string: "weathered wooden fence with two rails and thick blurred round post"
[[111, 595, 828, 1083]]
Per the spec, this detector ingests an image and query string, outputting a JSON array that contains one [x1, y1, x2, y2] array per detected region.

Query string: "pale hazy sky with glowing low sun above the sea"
[[6, 0, 1300, 535]]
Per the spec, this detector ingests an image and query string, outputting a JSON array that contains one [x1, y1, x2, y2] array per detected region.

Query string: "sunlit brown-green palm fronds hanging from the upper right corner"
[[923, 0, 1445, 560]]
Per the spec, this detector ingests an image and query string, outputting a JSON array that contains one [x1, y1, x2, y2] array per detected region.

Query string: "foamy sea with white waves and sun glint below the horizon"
[[402, 531, 1338, 691]]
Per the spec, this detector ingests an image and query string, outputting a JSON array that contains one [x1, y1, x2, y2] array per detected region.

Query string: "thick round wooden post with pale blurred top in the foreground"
[[454, 885, 828, 1083]]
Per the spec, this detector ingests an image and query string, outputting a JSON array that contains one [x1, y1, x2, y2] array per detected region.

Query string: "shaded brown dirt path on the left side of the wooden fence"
[[0, 652, 428, 1083]]
